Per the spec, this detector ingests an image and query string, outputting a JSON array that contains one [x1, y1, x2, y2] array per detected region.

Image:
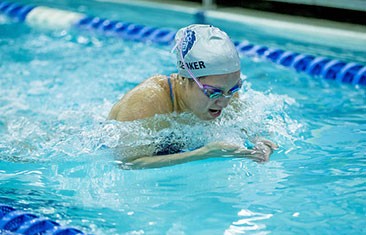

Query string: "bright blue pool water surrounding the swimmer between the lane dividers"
[[0, 1, 366, 234]]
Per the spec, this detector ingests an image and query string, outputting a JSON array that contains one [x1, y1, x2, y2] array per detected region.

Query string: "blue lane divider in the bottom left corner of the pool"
[[0, 204, 85, 235]]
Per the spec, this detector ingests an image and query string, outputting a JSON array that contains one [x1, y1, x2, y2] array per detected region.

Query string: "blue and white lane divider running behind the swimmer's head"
[[0, 0, 366, 86]]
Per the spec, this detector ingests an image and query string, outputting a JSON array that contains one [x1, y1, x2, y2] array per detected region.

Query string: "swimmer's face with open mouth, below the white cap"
[[188, 71, 241, 120]]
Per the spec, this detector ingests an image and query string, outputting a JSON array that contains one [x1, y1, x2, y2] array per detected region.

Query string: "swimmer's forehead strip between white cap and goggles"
[[200, 71, 240, 89]]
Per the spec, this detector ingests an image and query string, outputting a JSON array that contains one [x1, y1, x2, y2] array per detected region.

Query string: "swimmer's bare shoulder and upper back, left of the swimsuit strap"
[[108, 75, 173, 121]]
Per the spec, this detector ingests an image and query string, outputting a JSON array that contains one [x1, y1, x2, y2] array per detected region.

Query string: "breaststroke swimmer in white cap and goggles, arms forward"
[[108, 24, 277, 168]]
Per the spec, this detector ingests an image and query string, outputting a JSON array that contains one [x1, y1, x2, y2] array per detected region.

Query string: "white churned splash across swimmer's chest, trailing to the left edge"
[[0, 83, 301, 164]]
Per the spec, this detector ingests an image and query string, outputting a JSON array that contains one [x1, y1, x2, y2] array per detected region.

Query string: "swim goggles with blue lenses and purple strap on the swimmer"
[[172, 30, 243, 99]]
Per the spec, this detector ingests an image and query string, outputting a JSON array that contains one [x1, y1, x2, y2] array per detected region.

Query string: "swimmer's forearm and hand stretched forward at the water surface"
[[124, 142, 273, 169]]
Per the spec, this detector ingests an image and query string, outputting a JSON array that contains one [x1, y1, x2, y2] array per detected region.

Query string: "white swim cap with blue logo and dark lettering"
[[173, 24, 240, 78]]
